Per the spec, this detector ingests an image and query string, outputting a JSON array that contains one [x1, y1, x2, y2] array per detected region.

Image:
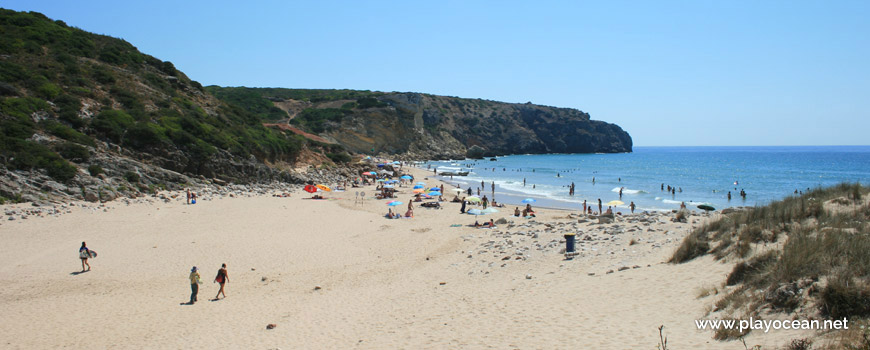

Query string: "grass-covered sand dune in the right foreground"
[[671, 184, 870, 338]]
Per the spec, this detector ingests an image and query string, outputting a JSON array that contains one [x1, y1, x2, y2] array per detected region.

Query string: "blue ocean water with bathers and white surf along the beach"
[[422, 146, 870, 211]]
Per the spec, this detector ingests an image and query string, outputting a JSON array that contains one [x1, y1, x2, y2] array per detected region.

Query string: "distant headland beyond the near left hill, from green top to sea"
[[206, 86, 632, 159]]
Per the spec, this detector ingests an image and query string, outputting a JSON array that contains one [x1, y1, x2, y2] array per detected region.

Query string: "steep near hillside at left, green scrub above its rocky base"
[[0, 9, 343, 200]]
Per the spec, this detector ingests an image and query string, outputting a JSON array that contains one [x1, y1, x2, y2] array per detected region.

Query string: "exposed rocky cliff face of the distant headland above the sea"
[[302, 93, 632, 159]]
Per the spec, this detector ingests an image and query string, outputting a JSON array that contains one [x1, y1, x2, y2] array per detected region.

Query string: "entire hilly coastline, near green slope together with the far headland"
[[0, 9, 631, 202]]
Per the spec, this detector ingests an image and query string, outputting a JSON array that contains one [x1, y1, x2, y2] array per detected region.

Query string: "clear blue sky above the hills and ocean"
[[0, 0, 870, 146]]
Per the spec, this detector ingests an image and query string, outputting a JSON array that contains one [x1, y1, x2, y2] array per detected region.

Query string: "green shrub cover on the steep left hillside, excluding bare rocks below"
[[0, 9, 314, 181]]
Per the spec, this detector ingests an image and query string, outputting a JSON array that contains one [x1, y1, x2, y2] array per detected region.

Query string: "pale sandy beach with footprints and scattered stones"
[[0, 166, 816, 349]]
